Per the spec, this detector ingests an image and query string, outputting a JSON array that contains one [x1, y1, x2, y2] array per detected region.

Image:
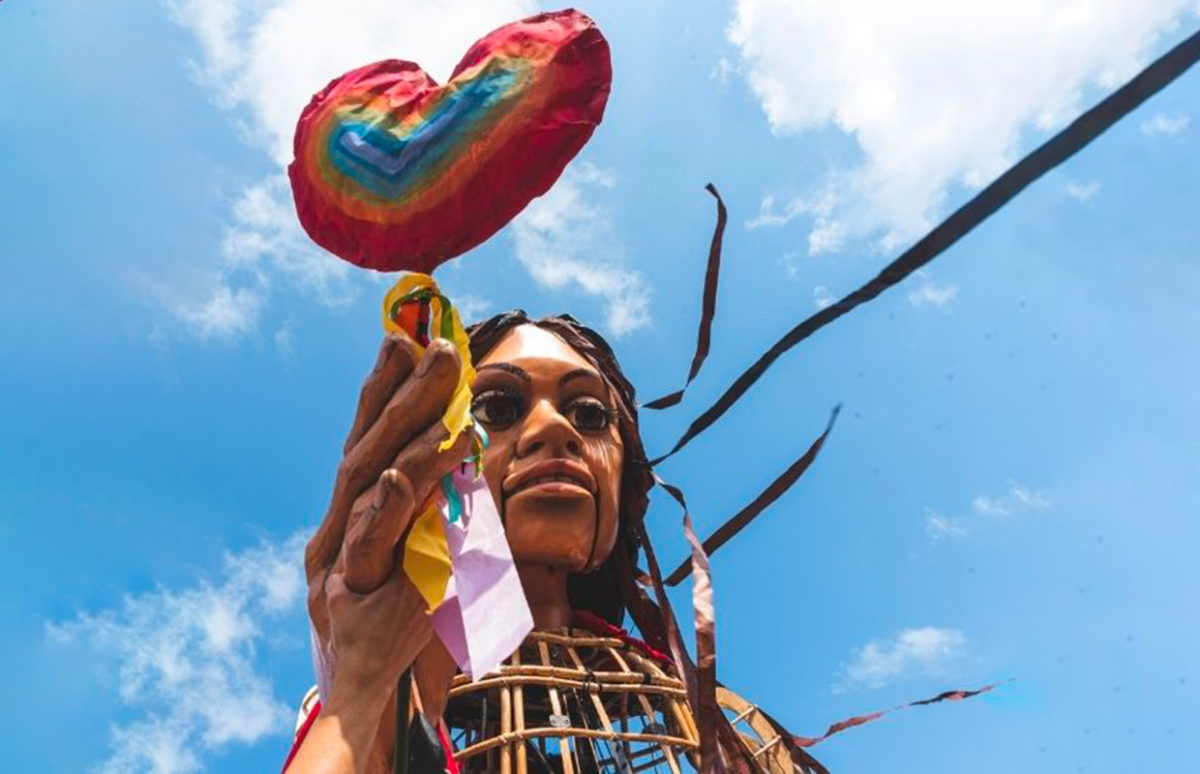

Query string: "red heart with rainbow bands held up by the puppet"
[[288, 10, 612, 274]]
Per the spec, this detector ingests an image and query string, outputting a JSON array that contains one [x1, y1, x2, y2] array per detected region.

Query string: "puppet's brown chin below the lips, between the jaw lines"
[[504, 492, 596, 572]]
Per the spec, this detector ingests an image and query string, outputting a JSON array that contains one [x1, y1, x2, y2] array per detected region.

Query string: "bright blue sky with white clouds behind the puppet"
[[0, 0, 1200, 774]]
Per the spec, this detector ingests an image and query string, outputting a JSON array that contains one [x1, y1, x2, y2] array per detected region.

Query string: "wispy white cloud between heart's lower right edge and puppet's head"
[[510, 163, 650, 336]]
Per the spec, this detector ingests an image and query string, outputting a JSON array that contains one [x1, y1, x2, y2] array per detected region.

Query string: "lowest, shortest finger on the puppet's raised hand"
[[342, 468, 414, 594]]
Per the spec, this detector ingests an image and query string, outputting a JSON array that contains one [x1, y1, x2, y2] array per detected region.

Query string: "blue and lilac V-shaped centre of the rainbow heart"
[[329, 66, 520, 200]]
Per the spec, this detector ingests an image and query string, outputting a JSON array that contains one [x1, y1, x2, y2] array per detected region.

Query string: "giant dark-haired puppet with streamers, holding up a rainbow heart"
[[276, 10, 1200, 774]]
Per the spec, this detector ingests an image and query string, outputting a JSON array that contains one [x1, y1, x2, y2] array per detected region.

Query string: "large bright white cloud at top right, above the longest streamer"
[[727, 0, 1195, 252]]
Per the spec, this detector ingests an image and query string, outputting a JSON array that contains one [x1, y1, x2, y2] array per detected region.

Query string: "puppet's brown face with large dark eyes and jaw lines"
[[472, 325, 624, 571]]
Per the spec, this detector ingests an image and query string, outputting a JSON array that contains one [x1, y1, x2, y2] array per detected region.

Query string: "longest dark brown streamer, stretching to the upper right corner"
[[650, 27, 1200, 464]]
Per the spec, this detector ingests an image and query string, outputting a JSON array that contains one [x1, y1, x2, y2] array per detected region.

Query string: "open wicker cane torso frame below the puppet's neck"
[[436, 629, 793, 774]]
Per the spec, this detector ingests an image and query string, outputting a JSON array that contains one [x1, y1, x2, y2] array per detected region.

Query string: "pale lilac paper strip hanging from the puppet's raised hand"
[[433, 472, 533, 679]]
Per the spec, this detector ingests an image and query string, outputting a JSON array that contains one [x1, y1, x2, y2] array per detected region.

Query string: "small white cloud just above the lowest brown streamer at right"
[[834, 626, 966, 690]]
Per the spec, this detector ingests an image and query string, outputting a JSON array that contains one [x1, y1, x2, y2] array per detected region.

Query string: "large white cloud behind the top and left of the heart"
[[157, 0, 535, 338]]
